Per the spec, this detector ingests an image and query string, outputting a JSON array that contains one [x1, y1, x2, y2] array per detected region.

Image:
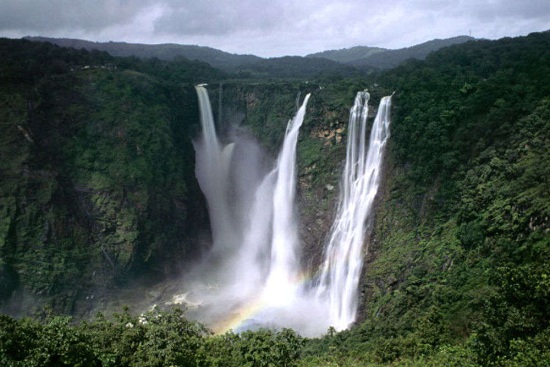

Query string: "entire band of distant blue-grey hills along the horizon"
[[25, 36, 474, 78]]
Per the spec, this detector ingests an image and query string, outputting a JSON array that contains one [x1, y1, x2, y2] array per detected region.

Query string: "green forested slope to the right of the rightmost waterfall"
[[302, 32, 550, 366]]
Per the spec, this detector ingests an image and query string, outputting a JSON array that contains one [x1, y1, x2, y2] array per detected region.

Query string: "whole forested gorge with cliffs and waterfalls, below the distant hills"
[[0, 32, 550, 367]]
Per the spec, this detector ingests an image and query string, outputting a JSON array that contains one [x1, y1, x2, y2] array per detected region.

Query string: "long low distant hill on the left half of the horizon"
[[25, 37, 262, 70]]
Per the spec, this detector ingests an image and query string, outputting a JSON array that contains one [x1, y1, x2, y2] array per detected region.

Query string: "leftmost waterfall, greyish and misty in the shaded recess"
[[194, 86, 271, 304]]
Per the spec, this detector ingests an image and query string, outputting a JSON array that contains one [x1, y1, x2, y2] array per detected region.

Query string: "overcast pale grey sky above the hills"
[[0, 0, 550, 57]]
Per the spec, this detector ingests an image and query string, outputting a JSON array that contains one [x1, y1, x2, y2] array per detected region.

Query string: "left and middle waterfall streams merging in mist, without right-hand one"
[[190, 86, 310, 334]]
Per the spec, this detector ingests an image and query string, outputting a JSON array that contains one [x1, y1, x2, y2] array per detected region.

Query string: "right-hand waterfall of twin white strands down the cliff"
[[317, 91, 391, 330]]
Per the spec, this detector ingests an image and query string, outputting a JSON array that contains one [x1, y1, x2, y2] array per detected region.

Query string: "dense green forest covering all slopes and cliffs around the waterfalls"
[[0, 32, 550, 366]]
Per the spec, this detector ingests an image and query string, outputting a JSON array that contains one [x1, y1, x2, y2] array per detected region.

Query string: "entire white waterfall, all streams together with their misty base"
[[185, 86, 390, 336]]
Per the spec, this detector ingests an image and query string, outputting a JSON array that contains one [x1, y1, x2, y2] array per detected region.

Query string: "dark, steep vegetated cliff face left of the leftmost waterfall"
[[0, 64, 208, 314]]
